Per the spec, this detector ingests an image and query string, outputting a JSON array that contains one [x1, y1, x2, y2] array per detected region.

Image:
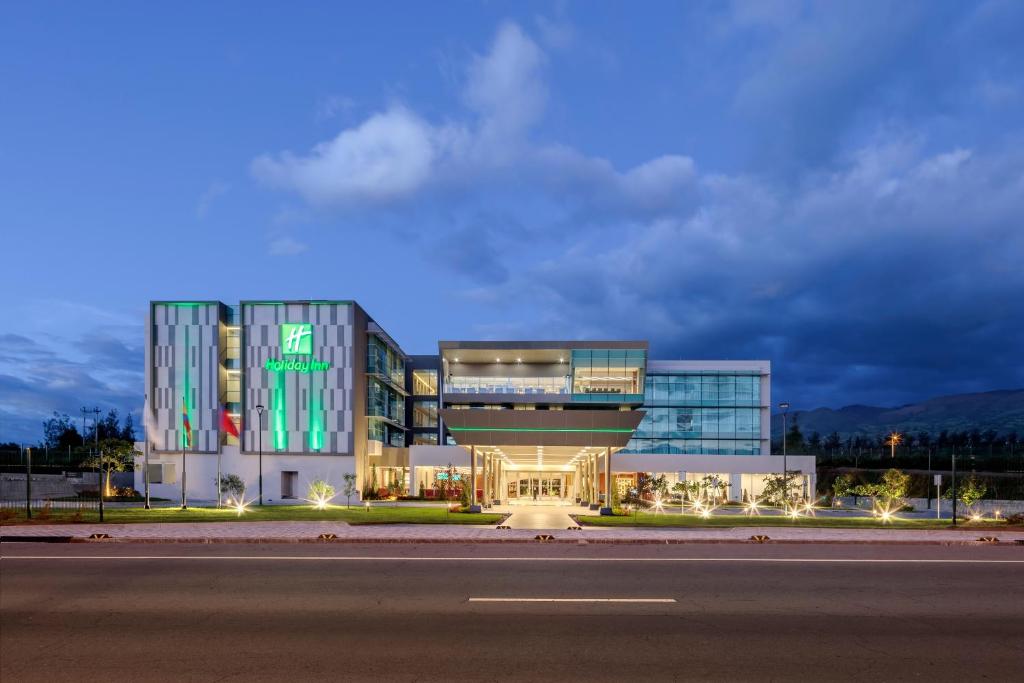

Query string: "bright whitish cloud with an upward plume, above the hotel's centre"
[[251, 23, 694, 212]]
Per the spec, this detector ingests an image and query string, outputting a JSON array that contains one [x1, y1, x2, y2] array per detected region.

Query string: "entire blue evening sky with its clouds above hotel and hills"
[[0, 1, 1024, 440]]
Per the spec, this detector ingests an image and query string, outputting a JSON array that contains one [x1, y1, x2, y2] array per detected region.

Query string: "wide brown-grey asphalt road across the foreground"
[[0, 544, 1024, 682]]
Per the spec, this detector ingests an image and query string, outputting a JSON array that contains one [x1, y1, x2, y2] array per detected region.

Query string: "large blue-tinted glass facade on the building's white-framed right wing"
[[624, 372, 762, 456]]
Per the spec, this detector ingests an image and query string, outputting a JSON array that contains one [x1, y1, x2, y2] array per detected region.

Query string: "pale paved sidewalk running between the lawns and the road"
[[0, 521, 1024, 545]]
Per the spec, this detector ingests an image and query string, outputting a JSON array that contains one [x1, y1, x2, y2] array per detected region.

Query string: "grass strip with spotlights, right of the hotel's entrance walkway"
[[577, 512, 1024, 531]]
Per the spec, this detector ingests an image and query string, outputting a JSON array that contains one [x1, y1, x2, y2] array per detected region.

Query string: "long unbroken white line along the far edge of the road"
[[0, 555, 1024, 564]]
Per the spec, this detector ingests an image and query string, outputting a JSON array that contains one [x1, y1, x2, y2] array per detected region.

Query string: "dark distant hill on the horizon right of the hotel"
[[772, 389, 1024, 438]]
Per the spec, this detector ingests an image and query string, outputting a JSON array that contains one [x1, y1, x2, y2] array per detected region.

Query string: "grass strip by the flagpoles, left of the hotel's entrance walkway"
[[2, 505, 503, 525]]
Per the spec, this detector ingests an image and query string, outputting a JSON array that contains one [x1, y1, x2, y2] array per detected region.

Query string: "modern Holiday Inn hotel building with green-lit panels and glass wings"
[[136, 300, 815, 509]]
